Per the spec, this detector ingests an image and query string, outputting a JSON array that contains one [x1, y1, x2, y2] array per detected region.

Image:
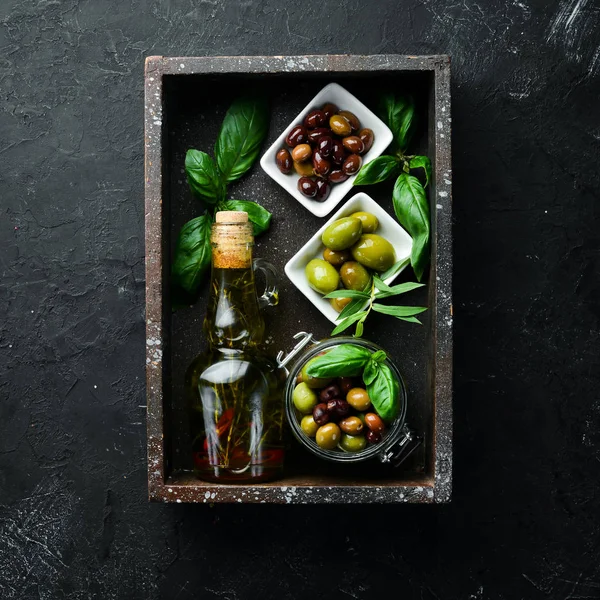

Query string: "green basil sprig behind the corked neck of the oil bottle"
[[171, 96, 271, 300]]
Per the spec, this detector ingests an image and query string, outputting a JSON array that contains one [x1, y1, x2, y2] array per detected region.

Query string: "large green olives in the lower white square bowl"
[[303, 211, 396, 312]]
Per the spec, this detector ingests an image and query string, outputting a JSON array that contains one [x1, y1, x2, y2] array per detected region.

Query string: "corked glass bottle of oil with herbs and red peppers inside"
[[186, 211, 285, 483]]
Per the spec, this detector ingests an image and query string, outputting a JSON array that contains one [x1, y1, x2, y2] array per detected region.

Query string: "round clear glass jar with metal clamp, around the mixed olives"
[[277, 331, 423, 467]]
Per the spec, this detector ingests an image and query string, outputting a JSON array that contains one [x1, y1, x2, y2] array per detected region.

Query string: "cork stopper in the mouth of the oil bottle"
[[210, 210, 254, 269]]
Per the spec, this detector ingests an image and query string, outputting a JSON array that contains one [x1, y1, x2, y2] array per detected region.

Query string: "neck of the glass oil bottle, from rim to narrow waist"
[[204, 223, 264, 350]]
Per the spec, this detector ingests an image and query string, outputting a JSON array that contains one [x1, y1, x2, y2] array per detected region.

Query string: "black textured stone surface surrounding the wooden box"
[[0, 0, 600, 600]]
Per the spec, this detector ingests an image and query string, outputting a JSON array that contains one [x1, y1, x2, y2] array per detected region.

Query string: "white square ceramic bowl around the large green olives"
[[285, 192, 412, 323]]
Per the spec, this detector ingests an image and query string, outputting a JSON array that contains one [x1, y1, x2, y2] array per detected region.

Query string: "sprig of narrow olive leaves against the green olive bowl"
[[323, 258, 427, 337]]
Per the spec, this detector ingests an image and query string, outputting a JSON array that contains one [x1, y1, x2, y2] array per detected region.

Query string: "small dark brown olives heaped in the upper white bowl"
[[275, 102, 375, 202]]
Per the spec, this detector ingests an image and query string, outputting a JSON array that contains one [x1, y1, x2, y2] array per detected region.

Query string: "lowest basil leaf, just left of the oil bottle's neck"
[[171, 214, 212, 294]]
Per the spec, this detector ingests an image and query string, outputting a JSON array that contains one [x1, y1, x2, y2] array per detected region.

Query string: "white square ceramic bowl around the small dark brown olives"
[[260, 83, 393, 217]]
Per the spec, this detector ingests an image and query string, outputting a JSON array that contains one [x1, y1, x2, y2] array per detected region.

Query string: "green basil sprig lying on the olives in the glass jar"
[[307, 342, 400, 423]]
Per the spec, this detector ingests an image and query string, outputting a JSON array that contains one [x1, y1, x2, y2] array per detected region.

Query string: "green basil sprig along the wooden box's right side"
[[353, 94, 431, 281]]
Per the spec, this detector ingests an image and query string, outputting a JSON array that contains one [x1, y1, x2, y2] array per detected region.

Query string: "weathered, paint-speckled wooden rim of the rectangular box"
[[145, 55, 452, 503]]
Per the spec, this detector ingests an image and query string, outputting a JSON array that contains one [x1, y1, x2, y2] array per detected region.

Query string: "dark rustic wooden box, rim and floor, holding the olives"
[[145, 55, 452, 503]]
